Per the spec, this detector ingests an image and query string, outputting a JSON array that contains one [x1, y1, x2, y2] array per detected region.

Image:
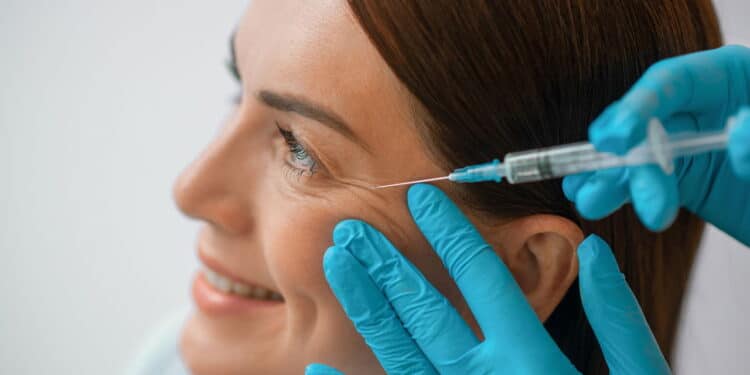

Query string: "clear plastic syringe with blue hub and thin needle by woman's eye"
[[375, 117, 734, 189]]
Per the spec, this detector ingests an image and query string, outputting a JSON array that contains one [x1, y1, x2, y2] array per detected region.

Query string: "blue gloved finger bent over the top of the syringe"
[[589, 46, 750, 155]]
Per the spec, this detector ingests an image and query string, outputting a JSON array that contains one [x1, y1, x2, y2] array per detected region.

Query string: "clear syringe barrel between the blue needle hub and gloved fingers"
[[503, 142, 628, 184]]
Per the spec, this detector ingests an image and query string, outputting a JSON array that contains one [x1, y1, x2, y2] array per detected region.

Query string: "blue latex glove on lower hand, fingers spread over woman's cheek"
[[306, 185, 669, 375]]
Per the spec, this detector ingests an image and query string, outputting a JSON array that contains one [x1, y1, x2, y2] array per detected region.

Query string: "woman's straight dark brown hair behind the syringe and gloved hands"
[[349, 0, 722, 373]]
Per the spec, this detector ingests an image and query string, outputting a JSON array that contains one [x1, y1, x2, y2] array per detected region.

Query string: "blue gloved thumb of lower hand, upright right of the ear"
[[578, 235, 670, 374]]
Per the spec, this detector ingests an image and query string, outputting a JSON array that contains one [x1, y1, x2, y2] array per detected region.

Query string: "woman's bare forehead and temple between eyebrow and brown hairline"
[[235, 0, 418, 149]]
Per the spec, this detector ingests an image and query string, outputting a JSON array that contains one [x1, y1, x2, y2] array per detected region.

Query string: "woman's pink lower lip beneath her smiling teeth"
[[193, 271, 284, 315]]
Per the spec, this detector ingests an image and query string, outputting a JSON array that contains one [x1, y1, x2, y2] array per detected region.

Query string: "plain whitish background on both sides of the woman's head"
[[0, 0, 750, 375]]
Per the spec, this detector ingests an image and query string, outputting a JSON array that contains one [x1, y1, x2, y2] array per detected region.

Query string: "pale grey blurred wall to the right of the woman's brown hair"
[[673, 0, 750, 375]]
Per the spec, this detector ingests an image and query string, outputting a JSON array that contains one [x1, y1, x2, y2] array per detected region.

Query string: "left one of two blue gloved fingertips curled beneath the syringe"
[[573, 168, 630, 220]]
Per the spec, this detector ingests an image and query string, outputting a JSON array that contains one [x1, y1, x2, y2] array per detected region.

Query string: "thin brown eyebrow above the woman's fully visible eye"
[[257, 90, 369, 152]]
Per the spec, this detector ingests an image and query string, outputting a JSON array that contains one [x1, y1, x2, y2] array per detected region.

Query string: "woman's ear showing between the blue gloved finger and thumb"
[[479, 215, 583, 321]]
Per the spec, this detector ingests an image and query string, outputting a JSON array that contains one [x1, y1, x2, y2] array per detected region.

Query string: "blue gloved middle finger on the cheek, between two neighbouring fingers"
[[333, 220, 479, 368]]
